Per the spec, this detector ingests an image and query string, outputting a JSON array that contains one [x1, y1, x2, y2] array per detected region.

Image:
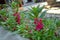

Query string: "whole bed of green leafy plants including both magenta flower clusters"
[[0, 2, 59, 40]]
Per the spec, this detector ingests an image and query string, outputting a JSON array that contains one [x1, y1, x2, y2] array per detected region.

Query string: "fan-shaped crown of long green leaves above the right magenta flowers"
[[29, 5, 46, 19]]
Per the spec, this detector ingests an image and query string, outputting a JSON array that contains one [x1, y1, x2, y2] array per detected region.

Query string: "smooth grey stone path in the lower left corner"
[[0, 27, 28, 40]]
